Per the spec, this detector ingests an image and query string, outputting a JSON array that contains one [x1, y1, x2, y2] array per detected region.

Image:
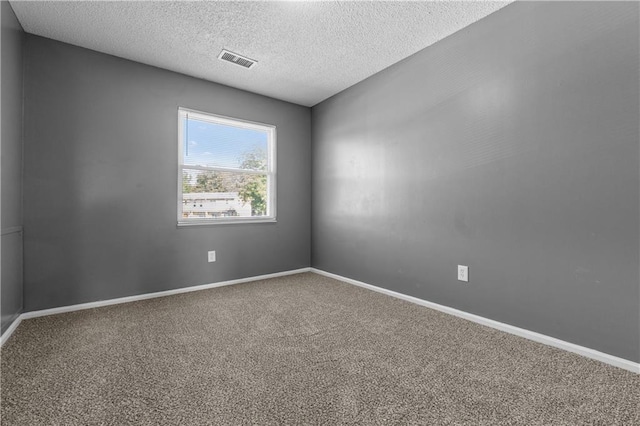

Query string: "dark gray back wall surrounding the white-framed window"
[[24, 35, 311, 311]]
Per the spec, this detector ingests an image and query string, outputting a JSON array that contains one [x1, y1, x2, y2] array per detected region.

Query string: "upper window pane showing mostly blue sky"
[[182, 117, 269, 171]]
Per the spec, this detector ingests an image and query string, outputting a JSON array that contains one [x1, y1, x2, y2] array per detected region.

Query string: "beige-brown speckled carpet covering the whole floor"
[[1, 273, 640, 426]]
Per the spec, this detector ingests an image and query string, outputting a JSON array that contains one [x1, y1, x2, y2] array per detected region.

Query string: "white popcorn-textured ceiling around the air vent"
[[11, 1, 508, 106]]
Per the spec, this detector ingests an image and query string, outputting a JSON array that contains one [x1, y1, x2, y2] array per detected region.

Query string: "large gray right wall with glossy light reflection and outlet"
[[312, 2, 640, 362]]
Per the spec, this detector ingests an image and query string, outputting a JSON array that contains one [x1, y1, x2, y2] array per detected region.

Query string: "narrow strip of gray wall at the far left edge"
[[0, 1, 24, 332]]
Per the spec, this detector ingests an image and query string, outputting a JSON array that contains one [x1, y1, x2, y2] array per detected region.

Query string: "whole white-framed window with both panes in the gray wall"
[[178, 108, 276, 225]]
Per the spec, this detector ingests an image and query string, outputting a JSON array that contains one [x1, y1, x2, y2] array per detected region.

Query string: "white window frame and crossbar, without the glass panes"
[[177, 107, 277, 226]]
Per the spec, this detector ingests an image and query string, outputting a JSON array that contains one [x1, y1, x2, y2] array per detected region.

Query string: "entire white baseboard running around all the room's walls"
[[0, 268, 640, 374]]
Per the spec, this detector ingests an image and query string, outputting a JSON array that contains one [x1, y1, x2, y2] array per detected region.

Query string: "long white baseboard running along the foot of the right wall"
[[311, 268, 640, 374]]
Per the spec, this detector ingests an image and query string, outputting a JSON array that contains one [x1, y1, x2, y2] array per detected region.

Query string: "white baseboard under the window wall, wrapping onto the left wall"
[[0, 268, 311, 346]]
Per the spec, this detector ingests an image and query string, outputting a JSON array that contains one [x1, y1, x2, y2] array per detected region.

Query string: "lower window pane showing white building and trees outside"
[[181, 169, 268, 220]]
